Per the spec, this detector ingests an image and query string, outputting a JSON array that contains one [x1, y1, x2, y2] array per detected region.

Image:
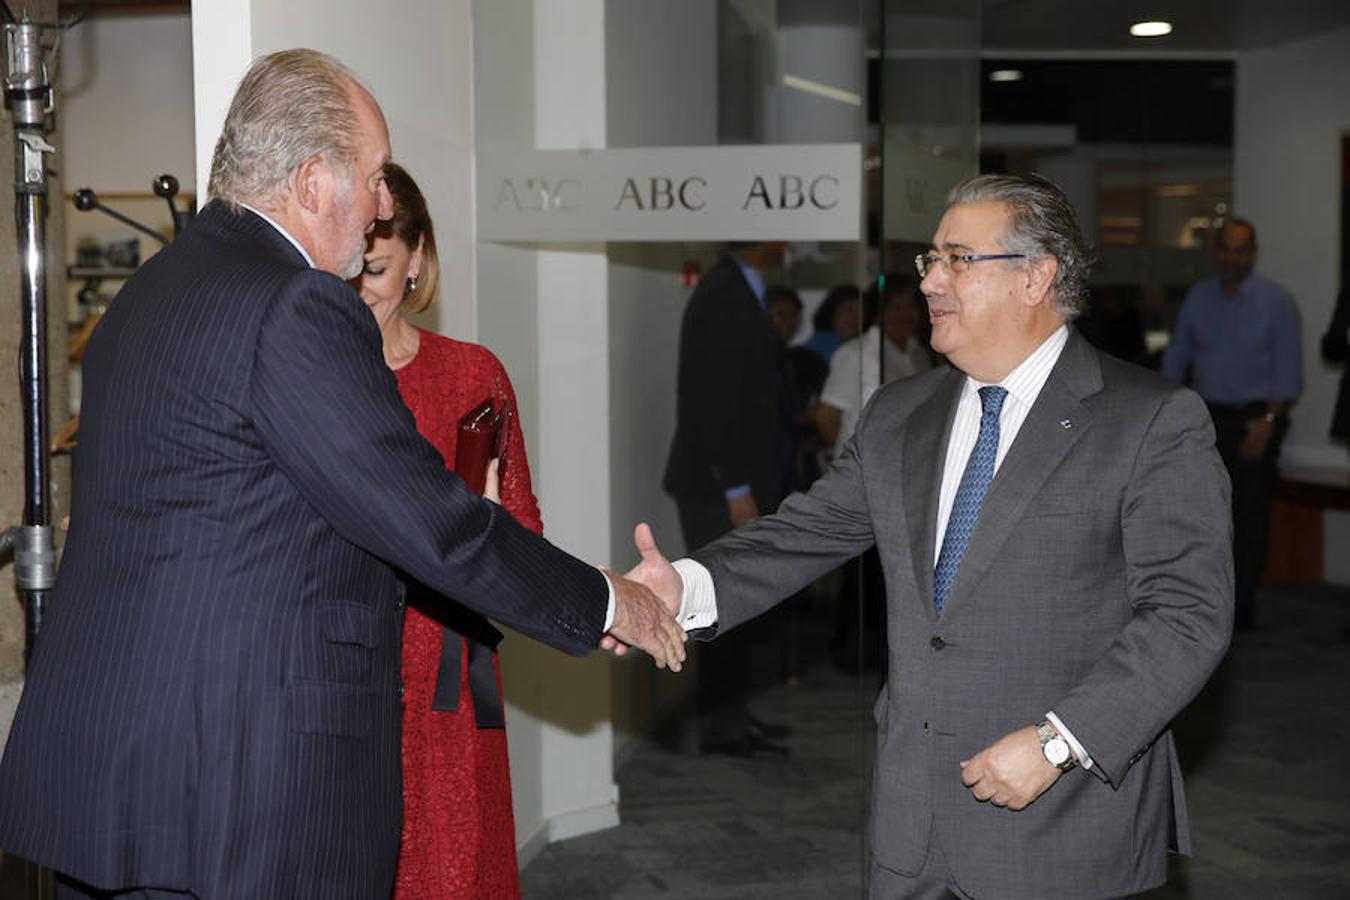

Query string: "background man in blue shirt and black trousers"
[[1162, 219, 1303, 629]]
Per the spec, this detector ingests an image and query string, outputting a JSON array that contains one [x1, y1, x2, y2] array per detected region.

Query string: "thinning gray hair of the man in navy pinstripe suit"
[[207, 49, 359, 208]]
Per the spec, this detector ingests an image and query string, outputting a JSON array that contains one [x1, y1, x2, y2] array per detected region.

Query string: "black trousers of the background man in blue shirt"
[[1210, 403, 1289, 629]]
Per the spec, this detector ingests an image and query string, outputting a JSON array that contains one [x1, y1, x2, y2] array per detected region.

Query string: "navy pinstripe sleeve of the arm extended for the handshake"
[[250, 270, 609, 654]]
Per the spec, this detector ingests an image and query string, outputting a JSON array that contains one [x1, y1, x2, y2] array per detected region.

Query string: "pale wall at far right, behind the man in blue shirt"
[[1234, 30, 1350, 468]]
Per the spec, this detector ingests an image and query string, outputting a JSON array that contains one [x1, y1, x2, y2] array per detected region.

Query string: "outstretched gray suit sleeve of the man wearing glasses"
[[691, 404, 875, 638]]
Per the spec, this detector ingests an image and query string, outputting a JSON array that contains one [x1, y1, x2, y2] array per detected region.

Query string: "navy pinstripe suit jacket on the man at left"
[[0, 204, 608, 900]]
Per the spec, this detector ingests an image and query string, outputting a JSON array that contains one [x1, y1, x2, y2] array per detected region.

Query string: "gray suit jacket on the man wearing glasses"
[[695, 332, 1233, 897]]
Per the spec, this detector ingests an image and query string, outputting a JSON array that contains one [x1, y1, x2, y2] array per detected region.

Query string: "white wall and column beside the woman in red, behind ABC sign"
[[474, 0, 618, 865]]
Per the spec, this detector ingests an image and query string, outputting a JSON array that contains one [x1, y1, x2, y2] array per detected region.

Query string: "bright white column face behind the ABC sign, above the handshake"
[[535, 0, 618, 841]]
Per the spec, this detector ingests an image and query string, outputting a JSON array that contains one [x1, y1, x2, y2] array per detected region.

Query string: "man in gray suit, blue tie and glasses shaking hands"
[[630, 175, 1233, 900]]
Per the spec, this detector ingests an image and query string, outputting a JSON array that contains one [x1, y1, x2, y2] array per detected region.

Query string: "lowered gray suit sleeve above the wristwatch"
[[1052, 390, 1233, 785]]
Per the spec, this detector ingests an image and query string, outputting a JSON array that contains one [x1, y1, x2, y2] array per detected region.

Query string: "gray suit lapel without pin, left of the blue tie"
[[900, 368, 965, 618]]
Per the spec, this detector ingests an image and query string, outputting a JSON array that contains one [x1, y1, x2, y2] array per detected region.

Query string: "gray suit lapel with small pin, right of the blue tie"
[[929, 329, 1102, 618]]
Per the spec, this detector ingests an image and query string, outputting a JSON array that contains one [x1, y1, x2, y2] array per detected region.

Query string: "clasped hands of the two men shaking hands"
[[599, 522, 687, 672]]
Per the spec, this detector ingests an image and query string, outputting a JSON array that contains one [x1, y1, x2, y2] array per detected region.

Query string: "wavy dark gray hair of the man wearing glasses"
[[946, 175, 1092, 320]]
